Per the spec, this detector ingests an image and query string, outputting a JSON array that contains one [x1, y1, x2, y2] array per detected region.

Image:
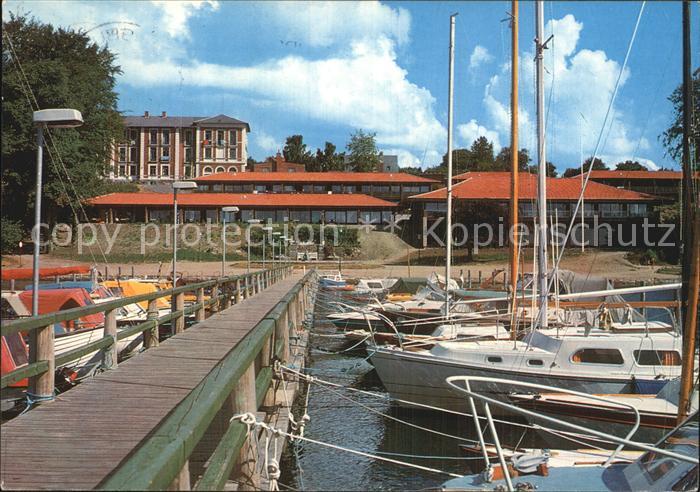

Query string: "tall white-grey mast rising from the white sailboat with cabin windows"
[[535, 0, 549, 328]]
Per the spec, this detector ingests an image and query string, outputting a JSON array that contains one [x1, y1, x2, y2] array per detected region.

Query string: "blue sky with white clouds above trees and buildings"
[[3, 0, 700, 171]]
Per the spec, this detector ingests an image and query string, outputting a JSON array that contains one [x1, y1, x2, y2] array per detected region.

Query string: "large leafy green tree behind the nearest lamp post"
[[2, 13, 124, 225]]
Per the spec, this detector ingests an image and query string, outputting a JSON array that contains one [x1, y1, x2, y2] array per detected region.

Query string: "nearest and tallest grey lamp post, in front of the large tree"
[[32, 109, 83, 316]]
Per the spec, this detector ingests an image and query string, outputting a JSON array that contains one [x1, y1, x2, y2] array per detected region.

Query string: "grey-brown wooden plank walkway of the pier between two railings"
[[0, 273, 302, 489]]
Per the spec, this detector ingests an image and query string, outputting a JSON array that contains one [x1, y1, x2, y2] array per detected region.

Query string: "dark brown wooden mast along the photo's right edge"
[[678, 0, 700, 422]]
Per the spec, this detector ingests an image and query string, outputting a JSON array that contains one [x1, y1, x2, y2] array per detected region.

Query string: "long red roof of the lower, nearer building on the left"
[[86, 193, 396, 208]]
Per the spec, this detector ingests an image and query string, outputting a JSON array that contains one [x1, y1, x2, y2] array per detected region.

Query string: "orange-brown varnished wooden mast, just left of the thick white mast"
[[510, 0, 519, 338]]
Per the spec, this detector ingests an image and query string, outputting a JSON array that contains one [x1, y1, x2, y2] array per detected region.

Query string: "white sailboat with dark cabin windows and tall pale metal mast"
[[371, 2, 693, 410]]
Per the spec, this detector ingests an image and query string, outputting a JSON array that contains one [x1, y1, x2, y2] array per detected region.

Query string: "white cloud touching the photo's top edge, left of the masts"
[[268, 1, 411, 47]]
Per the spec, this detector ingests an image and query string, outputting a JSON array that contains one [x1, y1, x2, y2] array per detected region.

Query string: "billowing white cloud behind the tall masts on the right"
[[476, 14, 655, 168]]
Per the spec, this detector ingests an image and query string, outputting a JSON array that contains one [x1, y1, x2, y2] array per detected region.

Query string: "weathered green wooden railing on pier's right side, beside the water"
[[97, 270, 317, 490]]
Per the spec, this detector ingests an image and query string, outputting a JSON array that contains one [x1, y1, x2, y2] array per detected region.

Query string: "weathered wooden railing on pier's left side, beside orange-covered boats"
[[0, 265, 291, 396]]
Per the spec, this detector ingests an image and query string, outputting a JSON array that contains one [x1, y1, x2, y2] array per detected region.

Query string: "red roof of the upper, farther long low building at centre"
[[194, 171, 438, 183]]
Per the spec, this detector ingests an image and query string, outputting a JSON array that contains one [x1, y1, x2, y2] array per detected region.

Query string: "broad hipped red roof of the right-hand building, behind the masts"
[[409, 172, 657, 201]]
